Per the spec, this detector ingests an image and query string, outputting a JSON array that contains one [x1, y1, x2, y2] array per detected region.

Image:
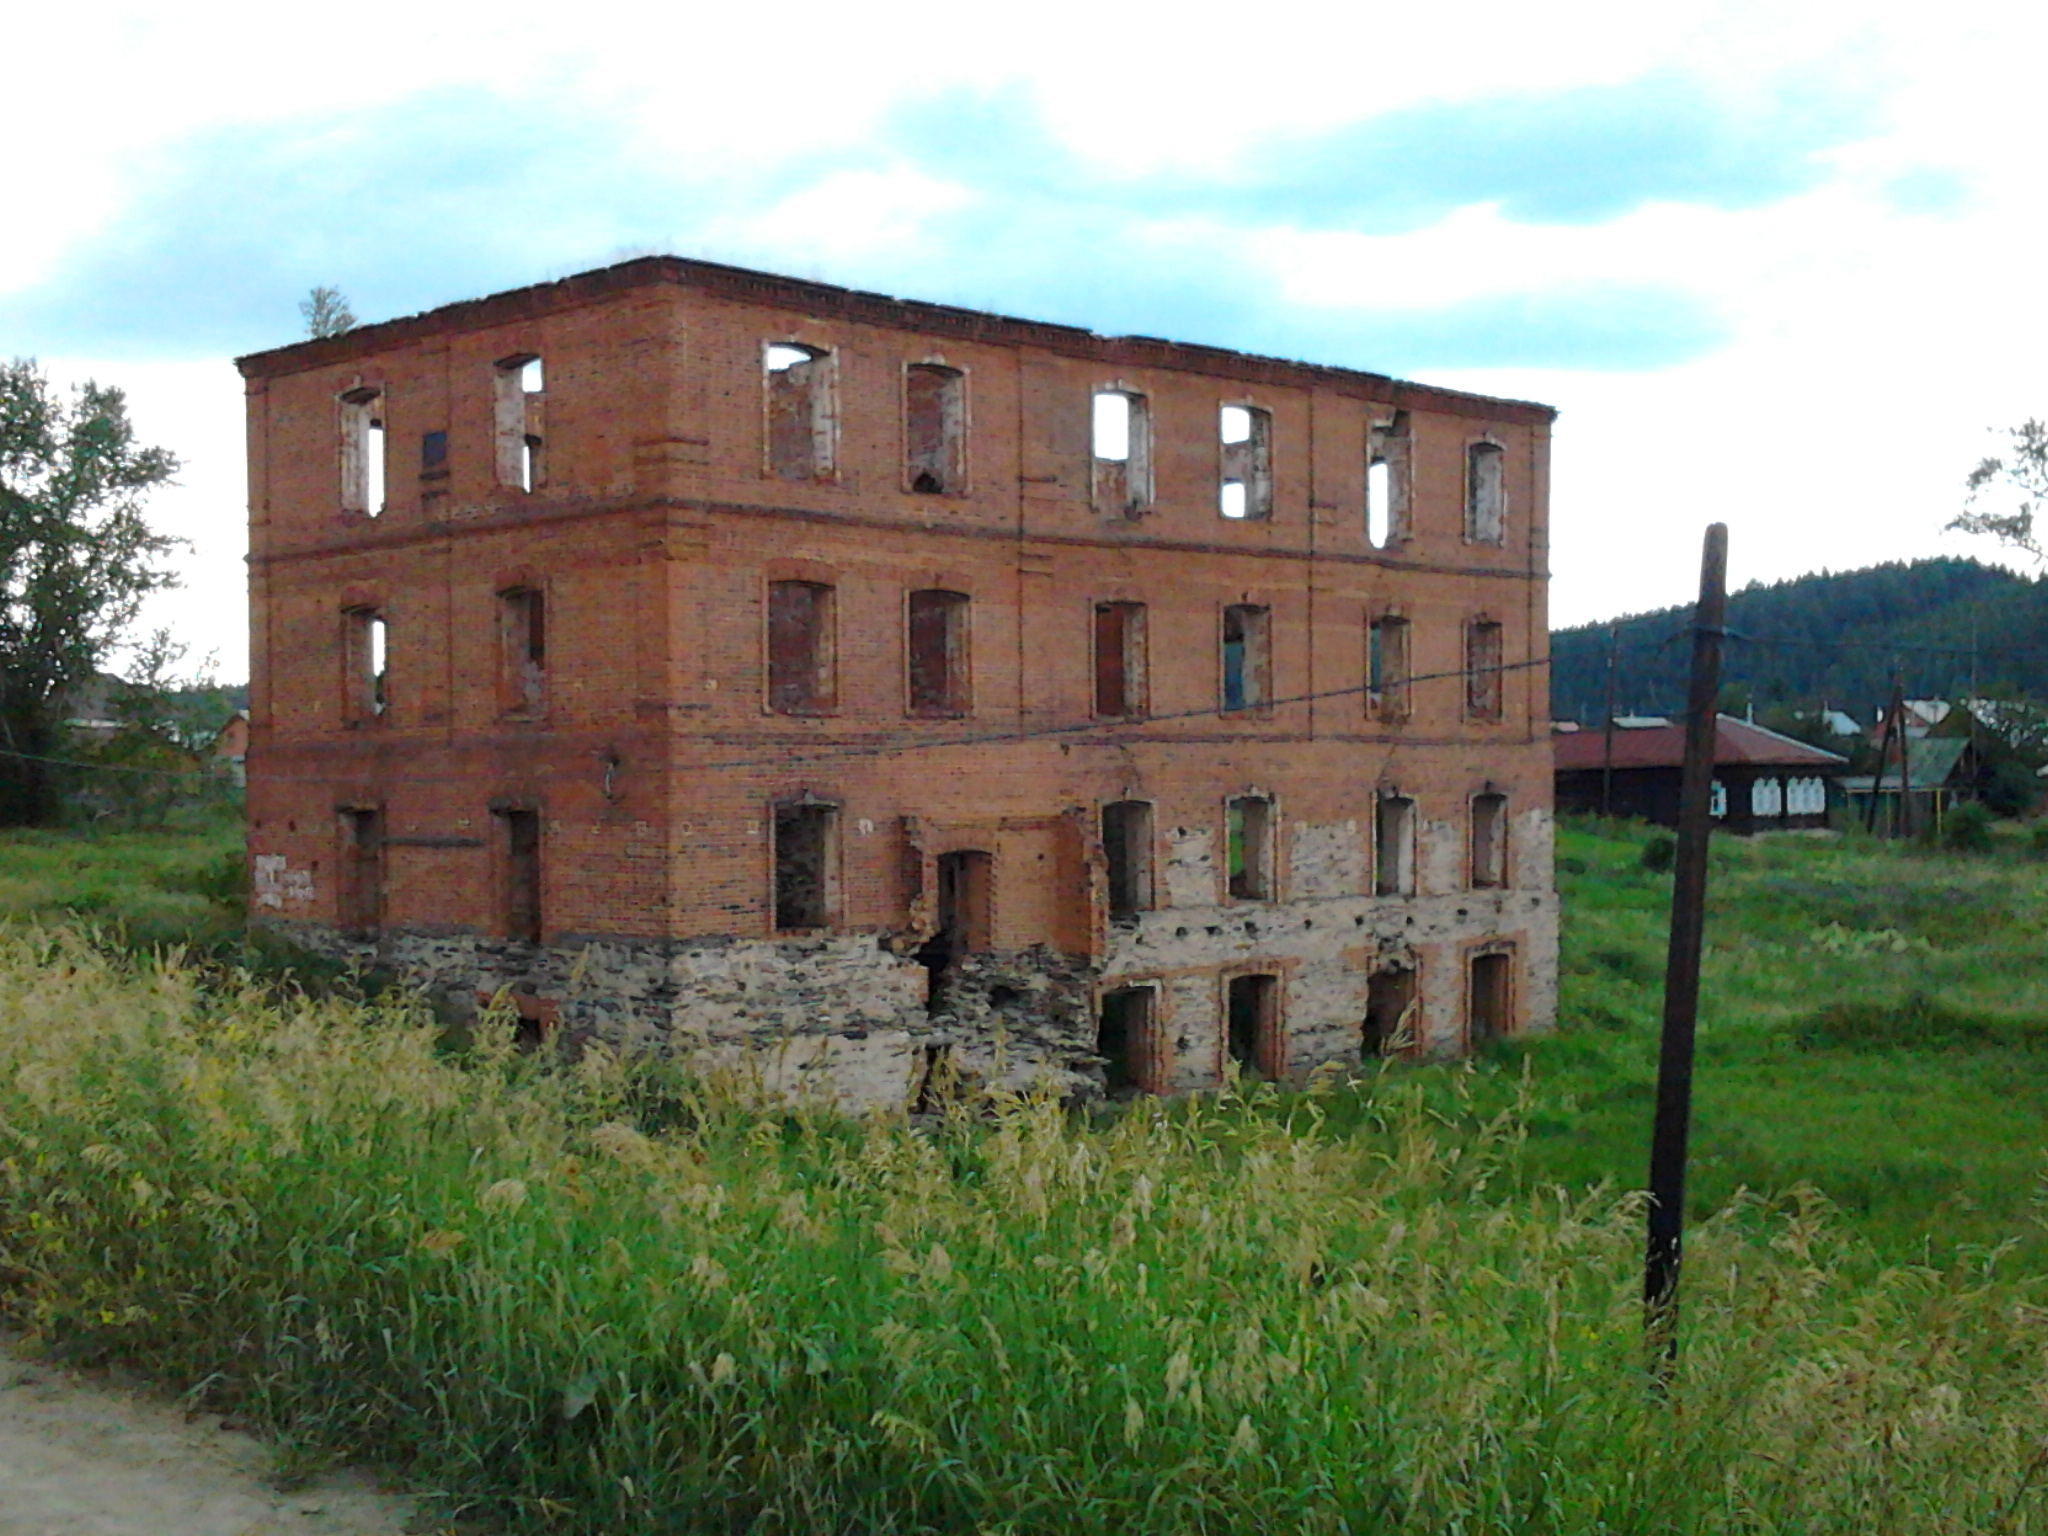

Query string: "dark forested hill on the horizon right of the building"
[[1550, 559, 2048, 725]]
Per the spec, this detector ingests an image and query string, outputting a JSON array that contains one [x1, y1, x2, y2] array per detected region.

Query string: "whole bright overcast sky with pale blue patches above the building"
[[0, 0, 2048, 680]]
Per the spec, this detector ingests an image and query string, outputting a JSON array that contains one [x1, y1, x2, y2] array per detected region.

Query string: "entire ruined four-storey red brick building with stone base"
[[242, 258, 1556, 1104]]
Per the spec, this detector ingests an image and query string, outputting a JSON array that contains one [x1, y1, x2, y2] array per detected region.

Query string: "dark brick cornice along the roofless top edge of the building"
[[236, 256, 1556, 424]]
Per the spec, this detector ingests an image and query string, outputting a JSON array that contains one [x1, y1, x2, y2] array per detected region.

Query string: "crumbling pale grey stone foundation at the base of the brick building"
[[270, 872, 1556, 1110]]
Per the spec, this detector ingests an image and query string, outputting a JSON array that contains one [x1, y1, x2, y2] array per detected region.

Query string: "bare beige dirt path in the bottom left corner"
[[0, 1337, 418, 1536]]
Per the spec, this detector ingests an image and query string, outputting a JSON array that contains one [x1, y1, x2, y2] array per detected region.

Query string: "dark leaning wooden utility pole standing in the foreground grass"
[[1642, 522, 1729, 1374]]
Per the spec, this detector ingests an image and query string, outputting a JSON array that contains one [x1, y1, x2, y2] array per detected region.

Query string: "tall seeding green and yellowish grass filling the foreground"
[[0, 934, 2048, 1536]]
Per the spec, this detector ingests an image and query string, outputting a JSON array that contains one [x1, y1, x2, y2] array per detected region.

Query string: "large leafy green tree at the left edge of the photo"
[[0, 358, 178, 825]]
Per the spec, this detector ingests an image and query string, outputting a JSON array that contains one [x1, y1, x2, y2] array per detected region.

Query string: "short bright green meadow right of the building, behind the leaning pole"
[[1523, 827, 2048, 1270]]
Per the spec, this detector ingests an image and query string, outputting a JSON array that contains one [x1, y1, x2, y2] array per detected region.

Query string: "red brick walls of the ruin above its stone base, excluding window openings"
[[244, 262, 1550, 1015]]
